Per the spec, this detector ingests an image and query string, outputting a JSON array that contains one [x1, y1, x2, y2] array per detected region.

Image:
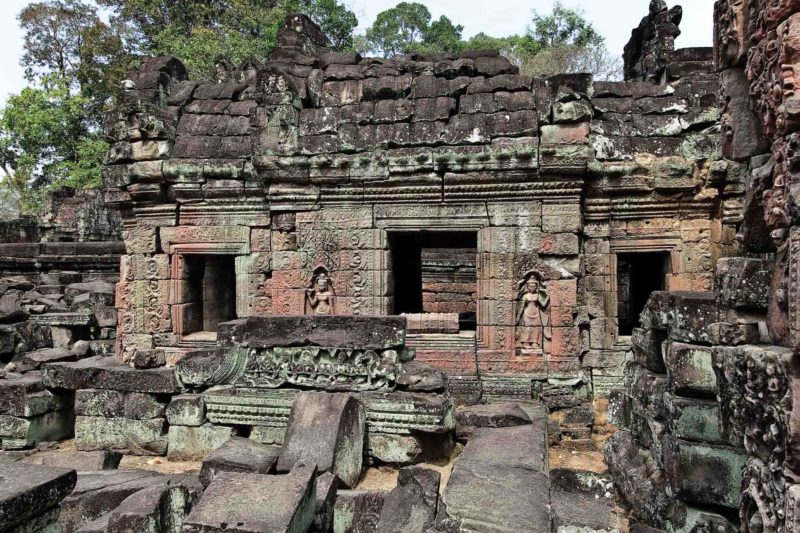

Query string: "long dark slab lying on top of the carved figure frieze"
[[218, 316, 405, 350]]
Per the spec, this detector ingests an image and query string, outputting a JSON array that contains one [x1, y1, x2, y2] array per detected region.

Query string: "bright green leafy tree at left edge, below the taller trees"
[[0, 76, 108, 213]]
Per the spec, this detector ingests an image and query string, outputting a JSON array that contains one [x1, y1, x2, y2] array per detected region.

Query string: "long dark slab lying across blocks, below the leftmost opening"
[[43, 357, 180, 394]]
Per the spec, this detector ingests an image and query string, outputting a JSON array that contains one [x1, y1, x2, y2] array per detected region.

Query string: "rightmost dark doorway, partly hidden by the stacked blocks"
[[617, 252, 669, 336]]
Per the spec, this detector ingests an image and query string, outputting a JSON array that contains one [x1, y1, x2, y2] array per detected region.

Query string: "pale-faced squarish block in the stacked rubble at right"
[[664, 341, 717, 398]]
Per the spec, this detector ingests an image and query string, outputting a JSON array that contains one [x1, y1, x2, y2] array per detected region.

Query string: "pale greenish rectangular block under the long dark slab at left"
[[75, 416, 167, 455]]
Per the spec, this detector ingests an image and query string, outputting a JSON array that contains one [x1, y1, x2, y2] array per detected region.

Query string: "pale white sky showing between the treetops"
[[0, 0, 714, 102]]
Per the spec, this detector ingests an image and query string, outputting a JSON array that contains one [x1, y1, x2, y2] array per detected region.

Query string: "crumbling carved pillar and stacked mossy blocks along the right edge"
[[607, 0, 800, 532]]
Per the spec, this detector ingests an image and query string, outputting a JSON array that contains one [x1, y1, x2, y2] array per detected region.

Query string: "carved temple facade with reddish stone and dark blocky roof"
[[105, 13, 736, 404]]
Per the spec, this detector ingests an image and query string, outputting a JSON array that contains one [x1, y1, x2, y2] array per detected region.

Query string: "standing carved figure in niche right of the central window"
[[515, 271, 553, 353]]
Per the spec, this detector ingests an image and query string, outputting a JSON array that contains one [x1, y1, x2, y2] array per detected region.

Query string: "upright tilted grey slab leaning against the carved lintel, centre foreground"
[[276, 392, 366, 487]]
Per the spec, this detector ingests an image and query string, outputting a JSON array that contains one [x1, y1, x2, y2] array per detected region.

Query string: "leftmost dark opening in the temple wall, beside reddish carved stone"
[[184, 255, 236, 334]]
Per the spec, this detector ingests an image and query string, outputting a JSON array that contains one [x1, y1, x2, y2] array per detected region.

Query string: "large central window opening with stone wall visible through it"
[[389, 231, 478, 329]]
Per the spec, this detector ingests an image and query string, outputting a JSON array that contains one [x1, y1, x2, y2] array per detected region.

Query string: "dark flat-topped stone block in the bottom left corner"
[[0, 462, 77, 531]]
